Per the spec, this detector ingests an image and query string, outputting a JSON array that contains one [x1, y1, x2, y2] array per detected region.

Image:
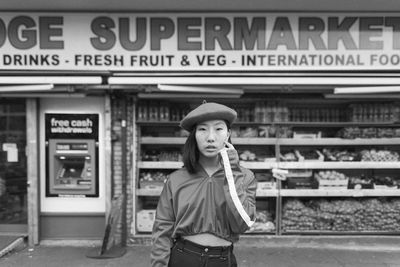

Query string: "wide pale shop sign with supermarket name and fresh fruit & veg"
[[0, 13, 400, 72]]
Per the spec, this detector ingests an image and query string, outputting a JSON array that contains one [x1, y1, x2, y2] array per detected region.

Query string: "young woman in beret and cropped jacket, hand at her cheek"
[[151, 103, 256, 267]]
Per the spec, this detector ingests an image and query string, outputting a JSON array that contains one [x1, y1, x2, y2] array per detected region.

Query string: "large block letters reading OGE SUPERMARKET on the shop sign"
[[0, 15, 400, 51]]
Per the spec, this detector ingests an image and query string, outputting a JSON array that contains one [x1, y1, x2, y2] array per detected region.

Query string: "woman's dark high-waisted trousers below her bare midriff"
[[168, 239, 237, 267]]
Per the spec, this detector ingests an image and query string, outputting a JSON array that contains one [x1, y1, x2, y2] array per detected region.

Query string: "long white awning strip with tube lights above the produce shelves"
[[108, 74, 400, 99]]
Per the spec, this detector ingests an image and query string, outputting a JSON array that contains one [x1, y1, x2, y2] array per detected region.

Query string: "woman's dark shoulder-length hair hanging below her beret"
[[182, 121, 231, 173]]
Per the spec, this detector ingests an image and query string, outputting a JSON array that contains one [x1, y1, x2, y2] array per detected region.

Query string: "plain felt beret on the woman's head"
[[180, 102, 237, 131]]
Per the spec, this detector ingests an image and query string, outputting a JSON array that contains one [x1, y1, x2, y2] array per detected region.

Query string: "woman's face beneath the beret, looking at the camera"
[[196, 120, 231, 158]]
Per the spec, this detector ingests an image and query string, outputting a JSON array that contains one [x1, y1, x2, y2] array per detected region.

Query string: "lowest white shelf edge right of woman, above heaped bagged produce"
[[280, 188, 400, 197]]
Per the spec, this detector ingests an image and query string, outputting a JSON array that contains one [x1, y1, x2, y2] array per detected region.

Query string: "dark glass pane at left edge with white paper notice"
[[0, 99, 27, 225]]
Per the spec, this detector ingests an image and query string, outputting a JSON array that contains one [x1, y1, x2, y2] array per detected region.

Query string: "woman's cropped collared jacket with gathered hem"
[[151, 150, 257, 267]]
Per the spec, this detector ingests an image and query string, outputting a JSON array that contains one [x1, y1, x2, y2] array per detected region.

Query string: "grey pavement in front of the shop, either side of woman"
[[0, 237, 400, 267]]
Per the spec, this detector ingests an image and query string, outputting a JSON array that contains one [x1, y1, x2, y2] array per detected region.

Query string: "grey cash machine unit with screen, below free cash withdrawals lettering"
[[47, 139, 98, 197]]
